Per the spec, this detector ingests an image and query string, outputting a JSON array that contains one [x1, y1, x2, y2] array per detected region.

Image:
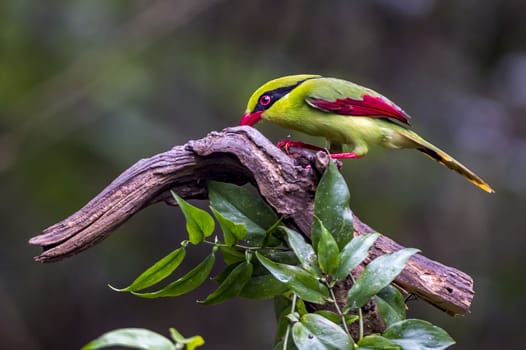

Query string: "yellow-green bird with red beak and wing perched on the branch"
[[240, 74, 495, 193]]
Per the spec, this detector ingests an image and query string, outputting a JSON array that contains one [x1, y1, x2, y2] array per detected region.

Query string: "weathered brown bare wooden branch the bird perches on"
[[29, 127, 474, 315]]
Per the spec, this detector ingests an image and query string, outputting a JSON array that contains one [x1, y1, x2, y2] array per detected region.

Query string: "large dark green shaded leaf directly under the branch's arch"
[[208, 181, 278, 244]]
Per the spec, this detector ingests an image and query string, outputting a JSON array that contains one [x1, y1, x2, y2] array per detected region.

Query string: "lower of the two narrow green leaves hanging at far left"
[[132, 253, 215, 299]]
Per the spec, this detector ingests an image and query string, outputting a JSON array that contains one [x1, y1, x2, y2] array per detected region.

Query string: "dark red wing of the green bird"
[[307, 94, 410, 125]]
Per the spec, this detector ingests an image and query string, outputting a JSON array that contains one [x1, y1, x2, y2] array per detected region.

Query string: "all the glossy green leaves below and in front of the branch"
[[86, 164, 454, 350]]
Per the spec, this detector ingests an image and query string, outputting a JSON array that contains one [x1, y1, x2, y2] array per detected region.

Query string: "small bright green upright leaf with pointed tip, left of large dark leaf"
[[172, 192, 215, 244]]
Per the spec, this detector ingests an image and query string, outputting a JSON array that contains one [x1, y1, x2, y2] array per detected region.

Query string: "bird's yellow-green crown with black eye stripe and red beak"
[[240, 74, 320, 126]]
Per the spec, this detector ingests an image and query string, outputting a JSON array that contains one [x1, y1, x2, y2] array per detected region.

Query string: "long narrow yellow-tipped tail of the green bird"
[[403, 130, 495, 193]]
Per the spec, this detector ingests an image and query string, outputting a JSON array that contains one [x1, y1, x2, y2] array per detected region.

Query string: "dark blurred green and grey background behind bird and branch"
[[0, 0, 526, 350]]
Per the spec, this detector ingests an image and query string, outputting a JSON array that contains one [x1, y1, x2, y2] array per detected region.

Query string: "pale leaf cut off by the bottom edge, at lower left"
[[81, 328, 175, 350]]
